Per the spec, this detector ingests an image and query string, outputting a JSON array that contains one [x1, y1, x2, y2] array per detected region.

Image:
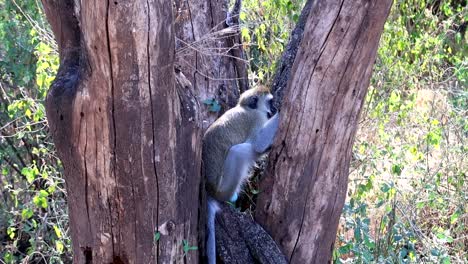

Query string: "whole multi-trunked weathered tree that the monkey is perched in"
[[43, 0, 391, 263]]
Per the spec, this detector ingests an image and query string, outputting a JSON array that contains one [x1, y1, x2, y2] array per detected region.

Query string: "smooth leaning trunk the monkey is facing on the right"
[[256, 0, 392, 263]]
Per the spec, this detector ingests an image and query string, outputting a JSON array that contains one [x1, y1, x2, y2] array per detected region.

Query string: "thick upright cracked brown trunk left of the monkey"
[[43, 0, 201, 263]]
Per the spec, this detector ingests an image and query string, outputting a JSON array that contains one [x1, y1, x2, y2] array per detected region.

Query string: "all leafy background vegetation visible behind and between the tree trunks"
[[0, 0, 468, 263]]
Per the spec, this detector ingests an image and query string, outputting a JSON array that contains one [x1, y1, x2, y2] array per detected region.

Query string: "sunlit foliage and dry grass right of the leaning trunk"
[[335, 1, 468, 263]]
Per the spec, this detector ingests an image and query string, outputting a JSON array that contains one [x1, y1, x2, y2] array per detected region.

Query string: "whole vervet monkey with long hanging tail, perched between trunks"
[[202, 87, 279, 264]]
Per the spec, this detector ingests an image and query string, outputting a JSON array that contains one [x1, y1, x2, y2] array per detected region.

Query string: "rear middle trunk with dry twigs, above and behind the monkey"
[[174, 0, 248, 128]]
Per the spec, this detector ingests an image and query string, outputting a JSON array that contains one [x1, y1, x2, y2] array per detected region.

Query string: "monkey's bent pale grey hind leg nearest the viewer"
[[218, 143, 257, 200]]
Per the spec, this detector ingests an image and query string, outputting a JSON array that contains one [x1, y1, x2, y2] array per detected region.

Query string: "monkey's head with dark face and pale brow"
[[239, 86, 273, 118]]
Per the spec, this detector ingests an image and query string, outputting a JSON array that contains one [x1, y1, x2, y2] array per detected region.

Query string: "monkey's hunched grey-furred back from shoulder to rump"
[[202, 106, 266, 199]]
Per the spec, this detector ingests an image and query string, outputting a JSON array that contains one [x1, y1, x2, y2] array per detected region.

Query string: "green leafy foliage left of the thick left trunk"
[[0, 0, 71, 263]]
